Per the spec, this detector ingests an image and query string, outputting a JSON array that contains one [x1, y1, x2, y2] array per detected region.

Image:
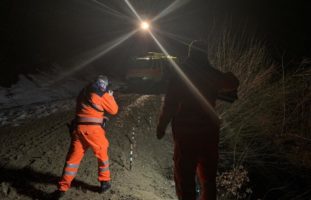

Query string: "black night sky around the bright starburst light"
[[0, 0, 311, 86]]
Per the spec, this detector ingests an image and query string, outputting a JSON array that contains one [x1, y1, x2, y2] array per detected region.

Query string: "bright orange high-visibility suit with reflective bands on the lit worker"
[[58, 85, 118, 191]]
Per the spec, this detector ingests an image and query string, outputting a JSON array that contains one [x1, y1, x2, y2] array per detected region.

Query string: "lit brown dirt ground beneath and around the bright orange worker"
[[0, 95, 176, 200]]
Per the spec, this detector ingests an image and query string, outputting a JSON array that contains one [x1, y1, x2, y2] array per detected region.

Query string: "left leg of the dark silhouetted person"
[[174, 143, 196, 200]]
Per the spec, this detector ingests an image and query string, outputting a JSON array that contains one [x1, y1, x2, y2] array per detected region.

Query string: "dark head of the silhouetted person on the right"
[[188, 40, 208, 63]]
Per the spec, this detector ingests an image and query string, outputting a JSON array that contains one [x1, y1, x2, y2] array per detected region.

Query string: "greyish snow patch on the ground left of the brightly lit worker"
[[0, 70, 122, 127]]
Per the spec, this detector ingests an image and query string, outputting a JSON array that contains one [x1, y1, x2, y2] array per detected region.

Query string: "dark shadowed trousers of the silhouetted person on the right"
[[173, 123, 218, 200]]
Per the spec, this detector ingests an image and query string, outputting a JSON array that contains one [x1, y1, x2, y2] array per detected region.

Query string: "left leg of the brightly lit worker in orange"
[[58, 133, 86, 191]]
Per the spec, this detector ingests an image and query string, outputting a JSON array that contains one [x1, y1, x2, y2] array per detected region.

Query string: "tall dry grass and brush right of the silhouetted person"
[[210, 30, 311, 199]]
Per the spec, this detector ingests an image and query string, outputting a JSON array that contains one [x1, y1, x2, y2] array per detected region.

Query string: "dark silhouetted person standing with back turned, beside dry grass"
[[157, 41, 239, 200]]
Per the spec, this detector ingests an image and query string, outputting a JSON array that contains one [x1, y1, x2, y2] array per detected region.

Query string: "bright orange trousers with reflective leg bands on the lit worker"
[[58, 125, 110, 191]]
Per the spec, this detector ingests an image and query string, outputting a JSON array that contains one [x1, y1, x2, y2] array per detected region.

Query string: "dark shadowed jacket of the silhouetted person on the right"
[[158, 59, 239, 144]]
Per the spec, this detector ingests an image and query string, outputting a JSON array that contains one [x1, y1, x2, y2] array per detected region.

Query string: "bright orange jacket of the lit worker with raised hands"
[[76, 84, 118, 123]]
